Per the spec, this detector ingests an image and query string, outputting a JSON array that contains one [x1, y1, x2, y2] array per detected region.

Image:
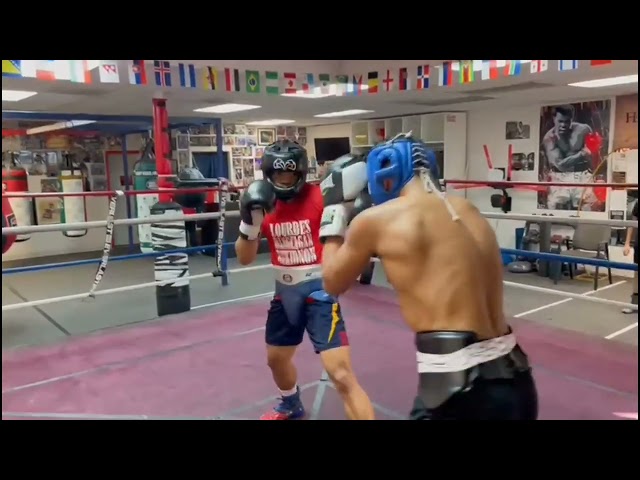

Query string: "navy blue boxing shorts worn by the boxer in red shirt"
[[265, 266, 349, 353]]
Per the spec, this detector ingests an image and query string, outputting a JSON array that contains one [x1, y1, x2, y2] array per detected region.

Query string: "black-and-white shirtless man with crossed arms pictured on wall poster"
[[542, 105, 593, 210]]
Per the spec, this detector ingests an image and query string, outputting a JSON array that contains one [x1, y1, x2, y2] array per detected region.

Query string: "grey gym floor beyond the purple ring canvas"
[[2, 256, 638, 349]]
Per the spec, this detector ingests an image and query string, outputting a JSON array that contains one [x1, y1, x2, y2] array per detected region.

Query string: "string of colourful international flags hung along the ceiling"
[[2, 60, 612, 96]]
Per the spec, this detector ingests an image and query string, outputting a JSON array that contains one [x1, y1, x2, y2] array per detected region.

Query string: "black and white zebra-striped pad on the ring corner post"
[[150, 201, 191, 317]]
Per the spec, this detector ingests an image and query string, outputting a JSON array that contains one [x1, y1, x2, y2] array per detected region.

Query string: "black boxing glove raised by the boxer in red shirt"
[[240, 180, 276, 240]]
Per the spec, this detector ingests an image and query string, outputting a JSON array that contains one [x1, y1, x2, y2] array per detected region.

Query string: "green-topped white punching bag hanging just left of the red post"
[[133, 141, 159, 253]]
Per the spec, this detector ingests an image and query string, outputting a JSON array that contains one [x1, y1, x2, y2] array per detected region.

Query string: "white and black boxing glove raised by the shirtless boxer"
[[320, 155, 368, 241]]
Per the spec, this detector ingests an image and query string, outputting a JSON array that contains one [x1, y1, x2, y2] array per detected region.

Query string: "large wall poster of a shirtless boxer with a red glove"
[[538, 100, 611, 212]]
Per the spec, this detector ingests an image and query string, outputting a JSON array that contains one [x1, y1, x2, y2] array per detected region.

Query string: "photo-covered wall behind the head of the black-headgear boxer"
[[175, 124, 317, 186]]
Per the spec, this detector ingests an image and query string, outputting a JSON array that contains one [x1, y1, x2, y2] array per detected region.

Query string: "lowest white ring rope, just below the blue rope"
[[2, 258, 638, 312]]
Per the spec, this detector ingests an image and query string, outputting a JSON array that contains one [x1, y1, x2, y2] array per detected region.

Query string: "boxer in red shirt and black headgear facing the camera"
[[236, 140, 374, 420]]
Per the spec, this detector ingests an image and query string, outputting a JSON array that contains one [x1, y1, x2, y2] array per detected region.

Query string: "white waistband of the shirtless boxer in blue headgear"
[[417, 333, 516, 373]]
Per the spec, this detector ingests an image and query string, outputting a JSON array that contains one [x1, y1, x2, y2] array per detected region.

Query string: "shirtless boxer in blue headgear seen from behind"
[[320, 135, 537, 420]]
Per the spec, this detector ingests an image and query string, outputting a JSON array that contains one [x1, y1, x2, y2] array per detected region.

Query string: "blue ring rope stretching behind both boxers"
[[2, 242, 638, 275]]
